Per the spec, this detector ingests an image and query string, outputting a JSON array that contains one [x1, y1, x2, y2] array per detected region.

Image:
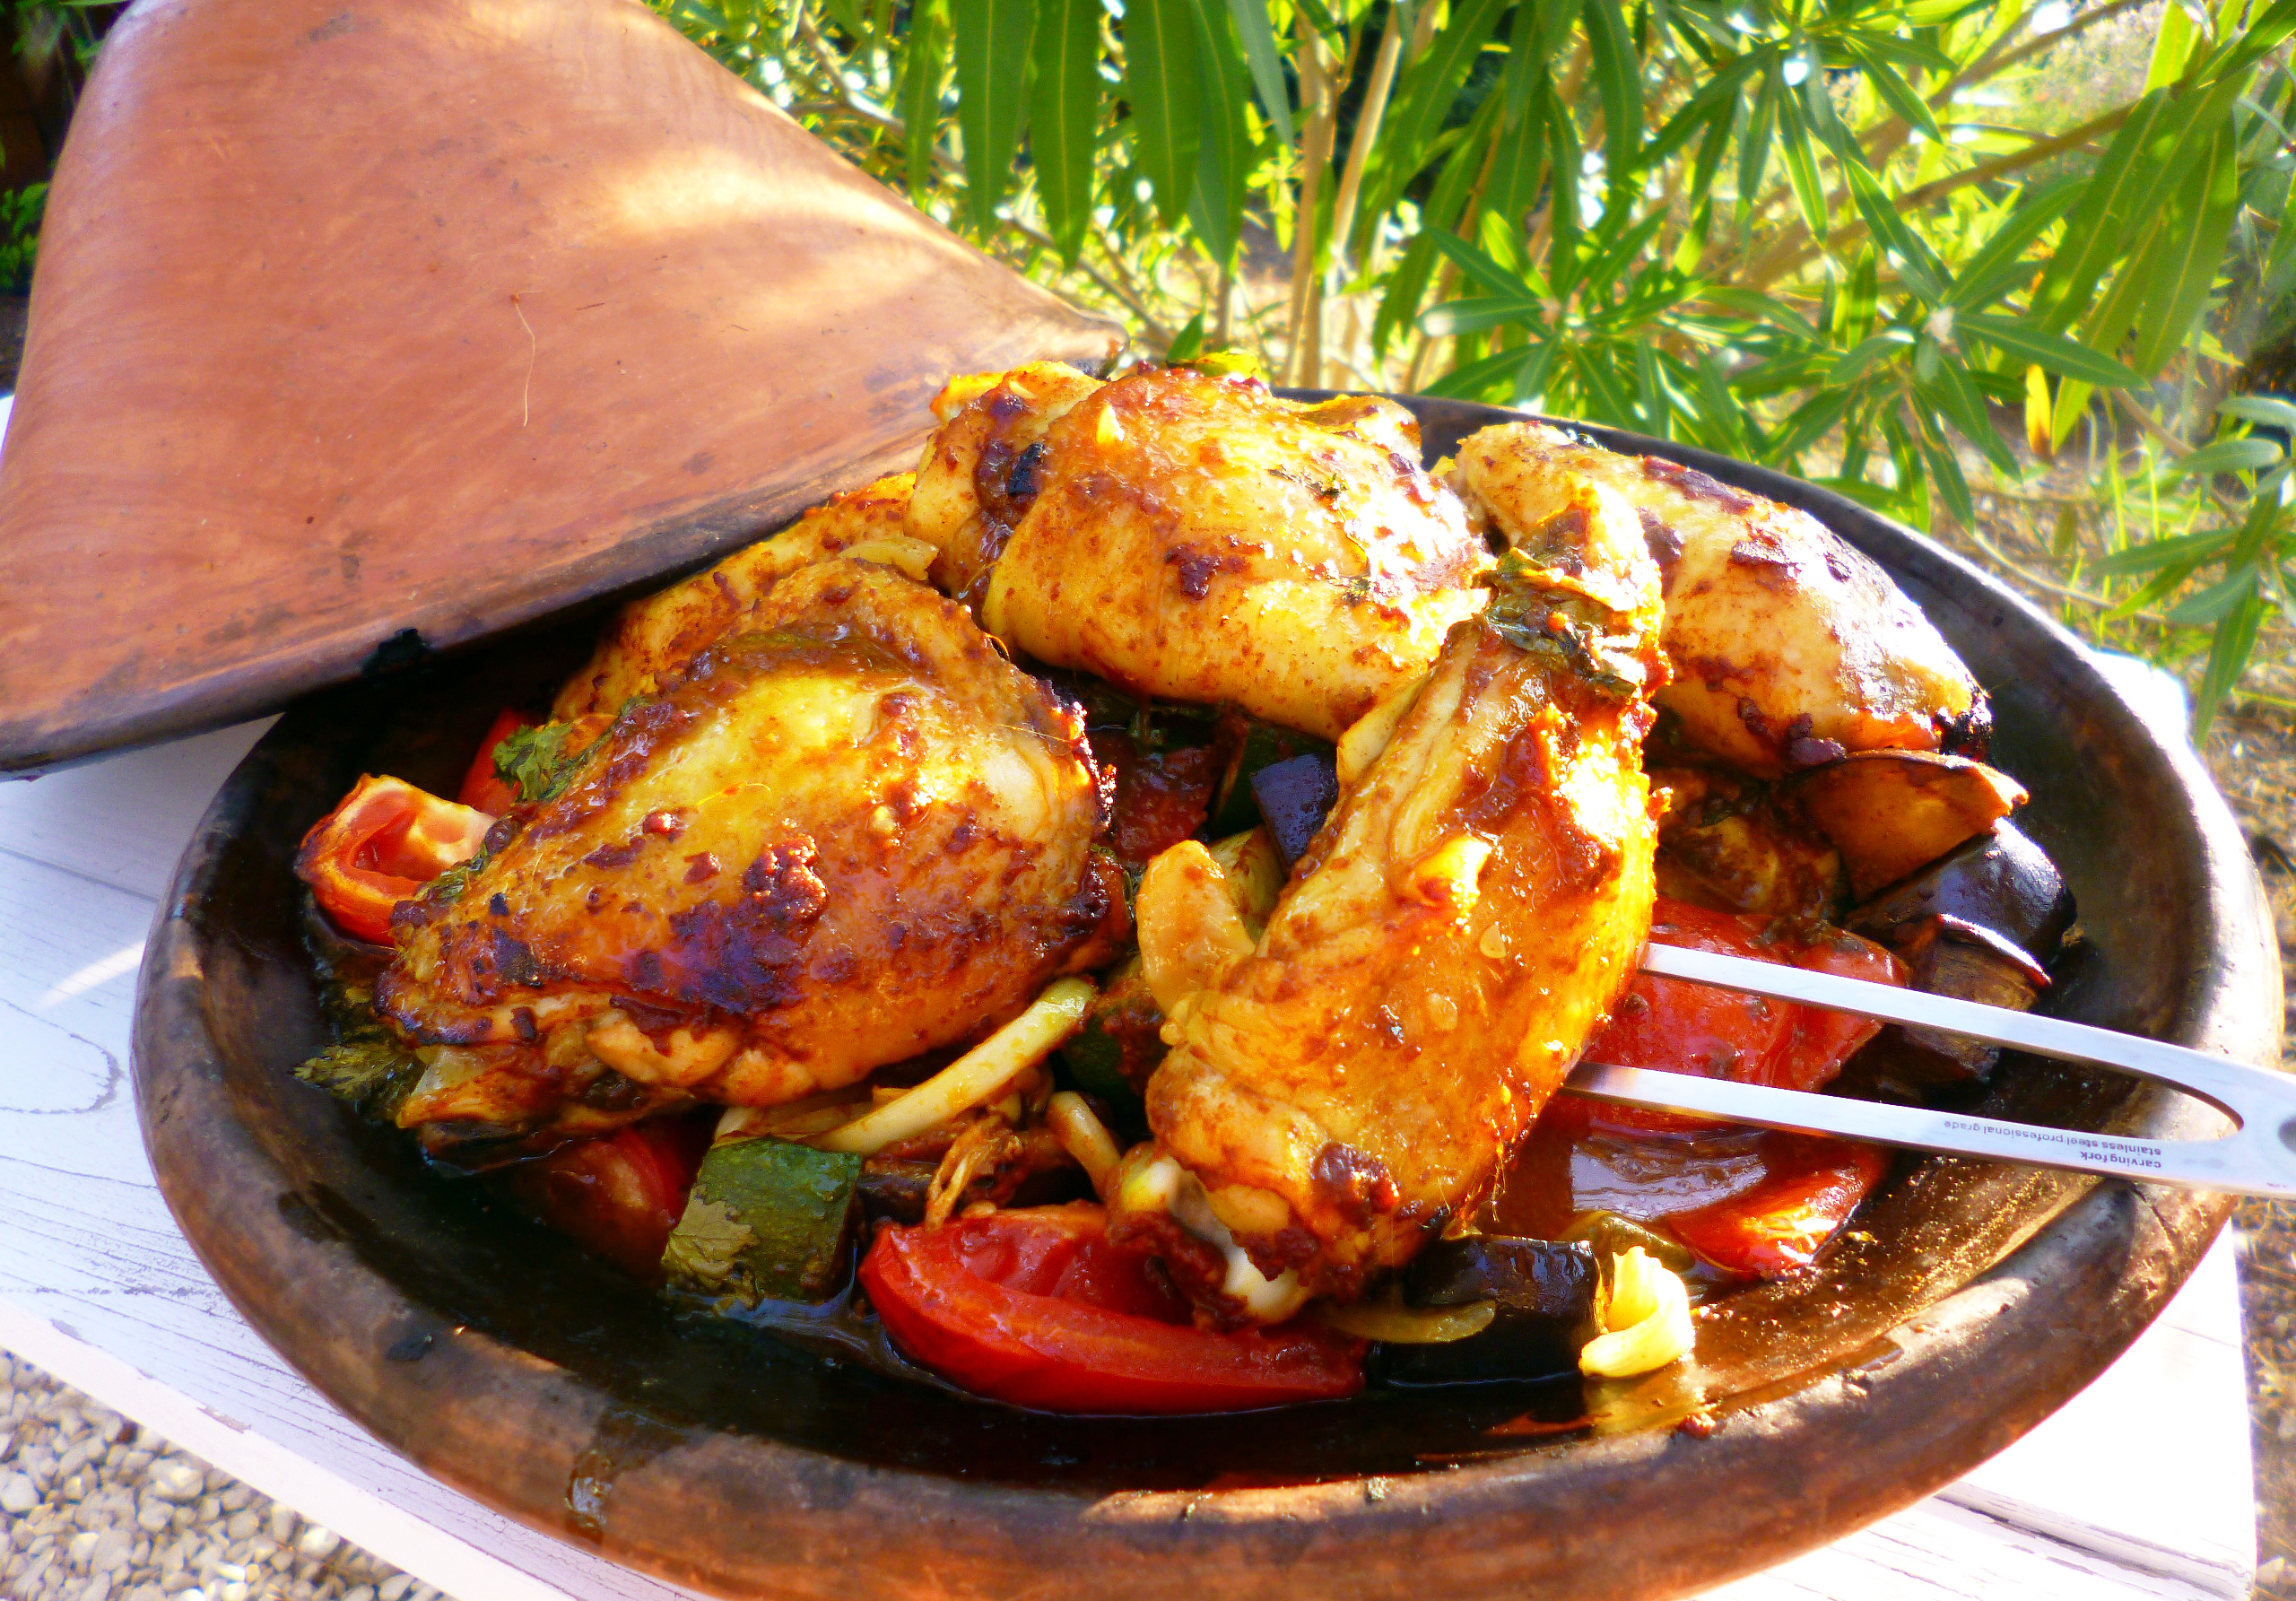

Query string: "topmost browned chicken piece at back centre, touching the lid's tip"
[[907, 368, 1490, 740]]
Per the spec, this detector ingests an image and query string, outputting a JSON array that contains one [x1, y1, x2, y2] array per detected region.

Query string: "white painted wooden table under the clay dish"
[[0, 724, 2255, 1601]]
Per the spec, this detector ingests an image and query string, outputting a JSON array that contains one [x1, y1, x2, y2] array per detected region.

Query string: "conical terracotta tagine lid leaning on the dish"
[[0, 0, 1118, 771]]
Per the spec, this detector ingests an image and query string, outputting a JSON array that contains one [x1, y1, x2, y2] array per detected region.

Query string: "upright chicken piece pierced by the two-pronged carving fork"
[[1114, 461, 1665, 1321]]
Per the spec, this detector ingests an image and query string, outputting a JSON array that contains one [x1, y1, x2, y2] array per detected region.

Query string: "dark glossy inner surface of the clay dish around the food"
[[157, 402, 2266, 1491]]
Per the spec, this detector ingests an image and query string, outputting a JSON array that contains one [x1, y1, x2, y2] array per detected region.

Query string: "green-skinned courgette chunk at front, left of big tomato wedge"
[[661, 1139, 861, 1305]]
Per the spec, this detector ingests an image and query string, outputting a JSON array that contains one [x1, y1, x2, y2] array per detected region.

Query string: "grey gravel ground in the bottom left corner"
[[0, 1355, 441, 1601]]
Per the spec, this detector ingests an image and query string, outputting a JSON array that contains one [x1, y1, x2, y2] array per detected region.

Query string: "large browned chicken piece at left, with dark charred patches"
[[377, 558, 1125, 1126]]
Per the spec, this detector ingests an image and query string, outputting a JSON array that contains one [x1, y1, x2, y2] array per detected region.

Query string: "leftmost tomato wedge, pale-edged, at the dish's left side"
[[294, 777, 493, 944]]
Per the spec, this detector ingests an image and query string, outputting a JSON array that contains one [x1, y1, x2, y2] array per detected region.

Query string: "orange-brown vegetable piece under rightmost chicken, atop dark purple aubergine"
[[1787, 751, 2025, 896]]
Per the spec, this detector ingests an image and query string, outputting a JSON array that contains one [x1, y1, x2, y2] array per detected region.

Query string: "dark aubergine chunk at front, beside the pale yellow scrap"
[[1373, 1233, 1603, 1388]]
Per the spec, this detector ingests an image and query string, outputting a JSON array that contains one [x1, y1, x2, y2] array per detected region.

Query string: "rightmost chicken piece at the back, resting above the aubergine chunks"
[[1451, 422, 1988, 779]]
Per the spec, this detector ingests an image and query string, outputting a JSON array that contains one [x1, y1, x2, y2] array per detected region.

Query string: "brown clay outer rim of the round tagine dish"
[[135, 400, 2280, 1597]]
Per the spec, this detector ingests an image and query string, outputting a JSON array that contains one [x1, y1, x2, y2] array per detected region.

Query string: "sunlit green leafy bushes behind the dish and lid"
[[655, 0, 2296, 719]]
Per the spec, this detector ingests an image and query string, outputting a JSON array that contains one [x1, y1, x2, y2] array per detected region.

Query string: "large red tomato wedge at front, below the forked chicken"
[[861, 1201, 1364, 1415]]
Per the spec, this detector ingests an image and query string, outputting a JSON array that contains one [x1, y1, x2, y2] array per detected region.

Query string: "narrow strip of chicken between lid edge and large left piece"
[[551, 474, 932, 719]]
